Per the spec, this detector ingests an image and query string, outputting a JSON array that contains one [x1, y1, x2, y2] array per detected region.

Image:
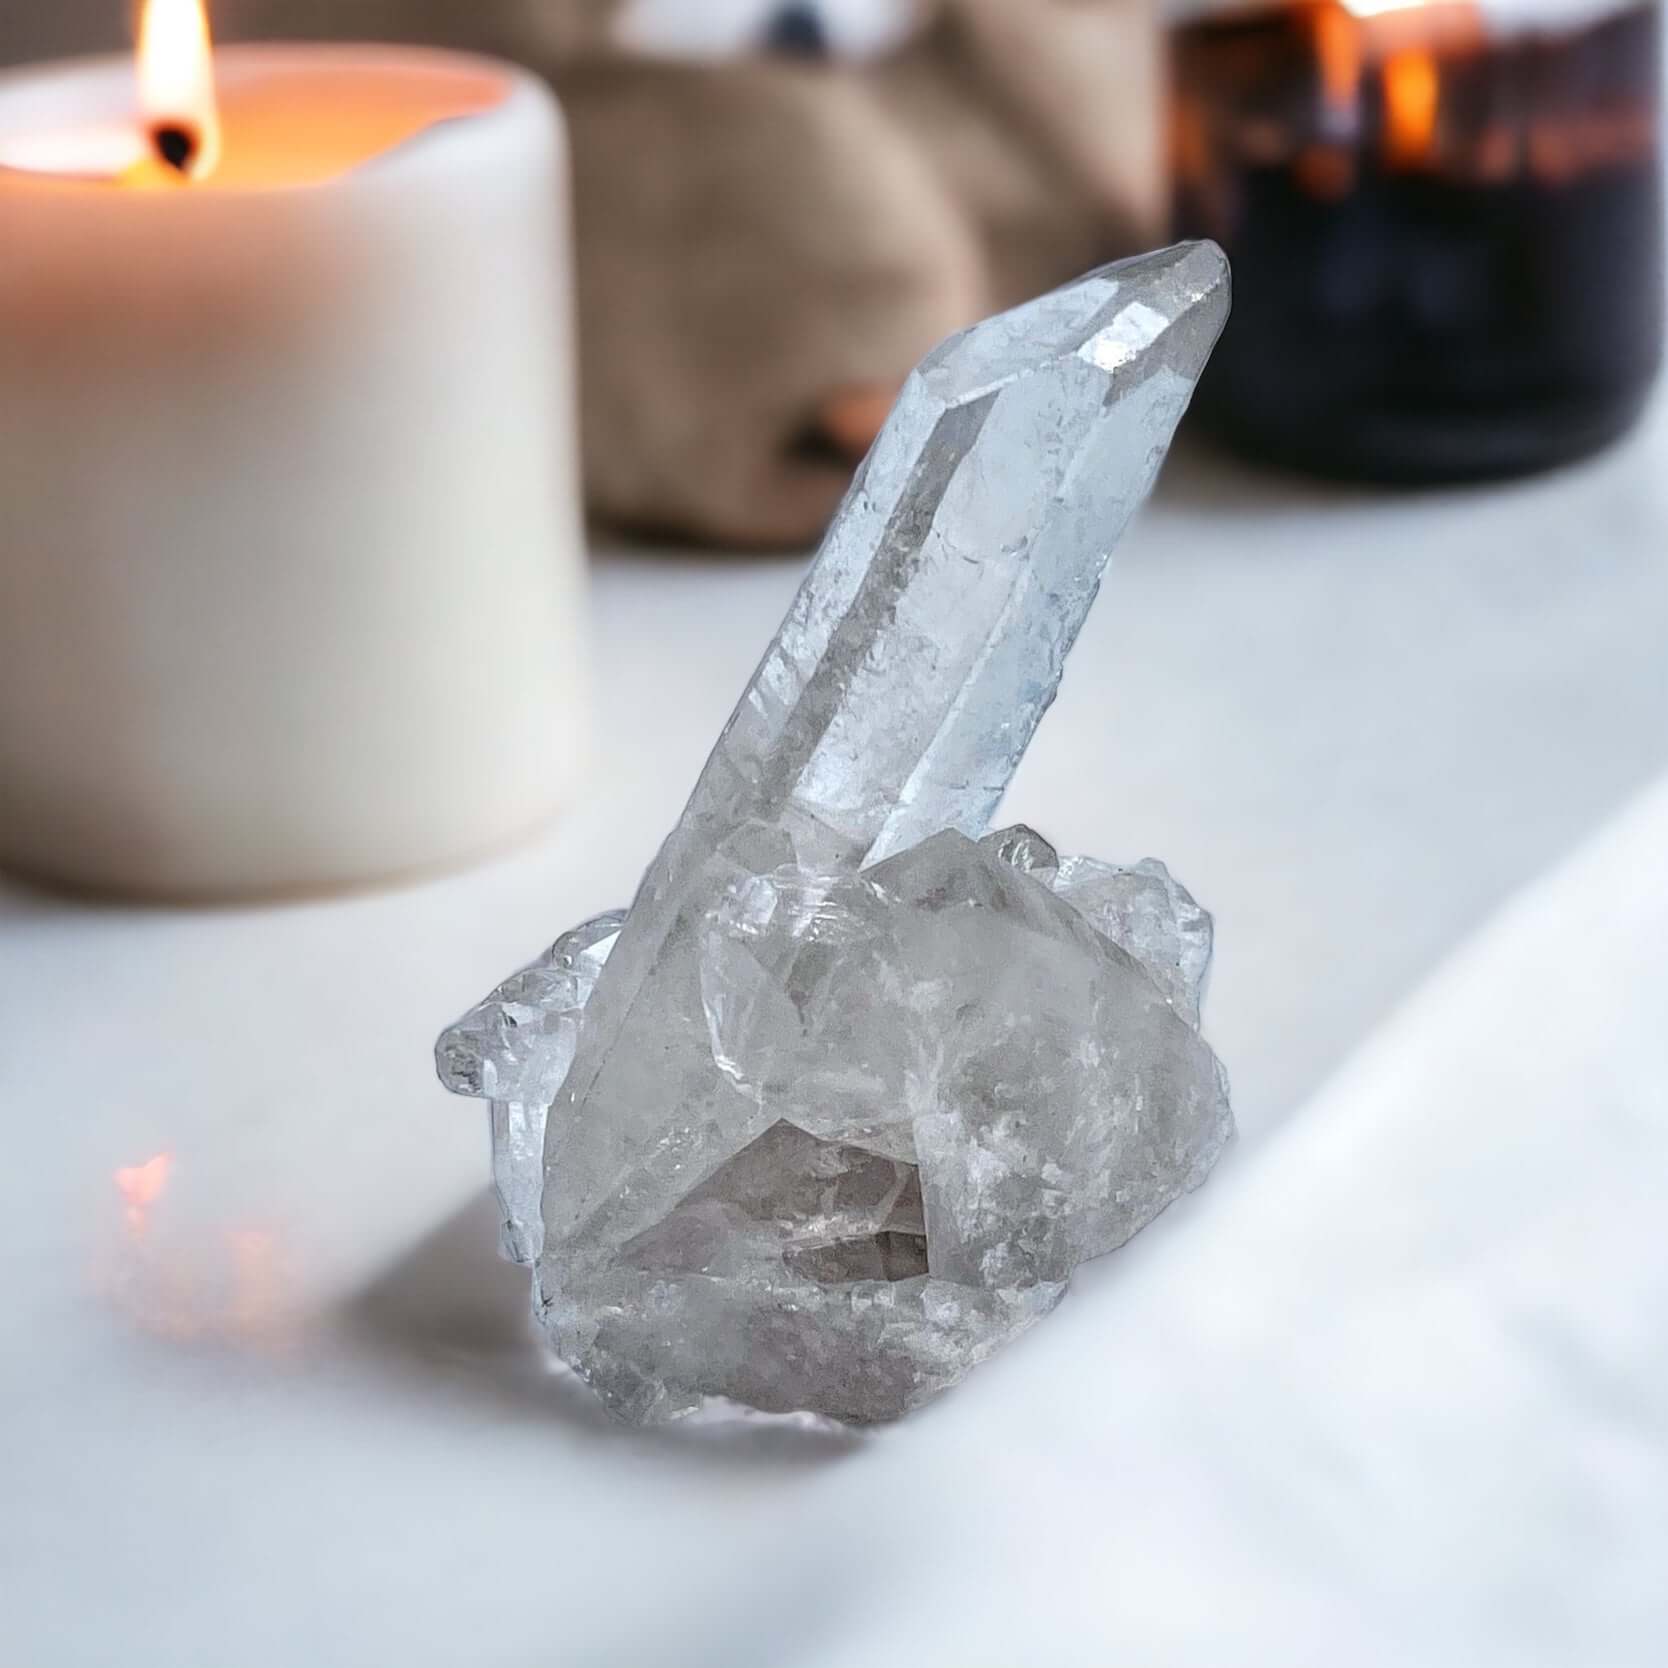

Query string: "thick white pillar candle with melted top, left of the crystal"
[[0, 47, 582, 897]]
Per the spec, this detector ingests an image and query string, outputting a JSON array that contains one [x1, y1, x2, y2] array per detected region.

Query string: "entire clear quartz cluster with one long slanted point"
[[437, 244, 1233, 1423]]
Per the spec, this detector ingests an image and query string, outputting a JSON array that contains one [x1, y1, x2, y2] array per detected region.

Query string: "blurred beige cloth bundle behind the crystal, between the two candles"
[[217, 0, 1161, 545]]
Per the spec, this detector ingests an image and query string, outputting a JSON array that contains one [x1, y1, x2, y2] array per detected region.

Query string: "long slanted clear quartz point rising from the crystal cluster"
[[544, 244, 1228, 1258]]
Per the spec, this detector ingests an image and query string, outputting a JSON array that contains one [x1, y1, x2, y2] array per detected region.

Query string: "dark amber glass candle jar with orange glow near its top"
[[1171, 0, 1665, 482]]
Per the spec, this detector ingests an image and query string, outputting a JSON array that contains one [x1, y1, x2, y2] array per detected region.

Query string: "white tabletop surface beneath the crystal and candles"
[[0, 405, 1668, 1668]]
